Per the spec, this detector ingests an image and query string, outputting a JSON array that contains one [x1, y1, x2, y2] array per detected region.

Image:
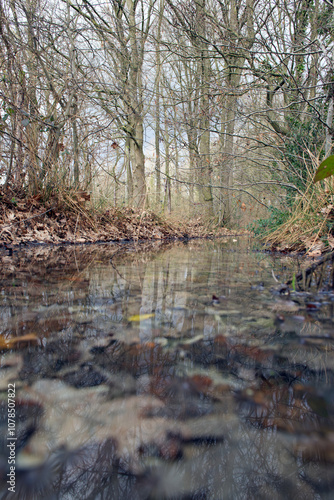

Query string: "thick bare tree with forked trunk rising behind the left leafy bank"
[[68, 0, 156, 207]]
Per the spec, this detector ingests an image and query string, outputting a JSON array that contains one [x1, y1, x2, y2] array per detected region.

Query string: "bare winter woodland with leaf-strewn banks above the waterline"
[[0, 0, 334, 249]]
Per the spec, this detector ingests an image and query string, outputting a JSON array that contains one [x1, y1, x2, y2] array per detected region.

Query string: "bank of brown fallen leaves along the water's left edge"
[[0, 188, 240, 247]]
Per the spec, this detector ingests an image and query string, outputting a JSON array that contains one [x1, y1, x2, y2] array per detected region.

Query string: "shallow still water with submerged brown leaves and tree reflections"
[[0, 238, 334, 500]]
